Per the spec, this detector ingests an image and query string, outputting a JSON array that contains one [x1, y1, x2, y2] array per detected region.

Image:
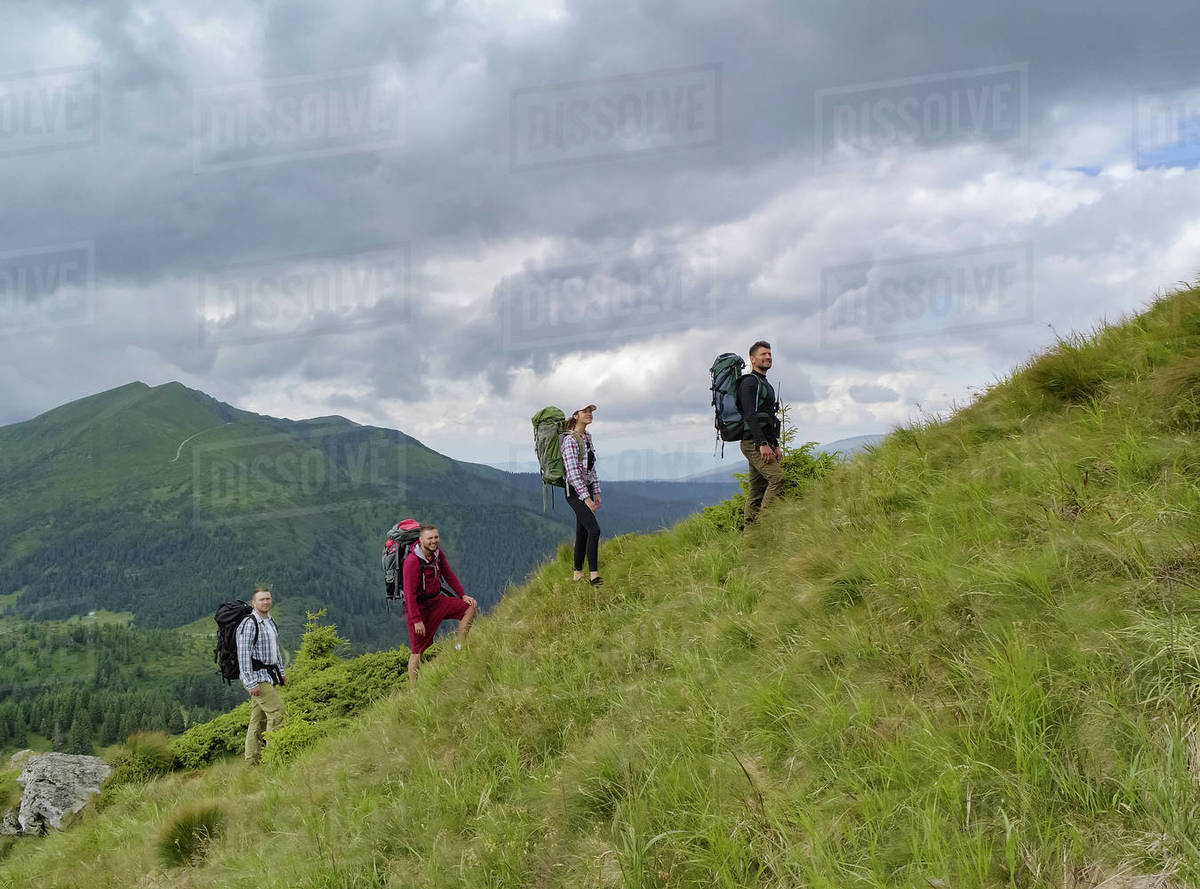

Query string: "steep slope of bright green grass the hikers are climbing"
[[0, 292, 1200, 889]]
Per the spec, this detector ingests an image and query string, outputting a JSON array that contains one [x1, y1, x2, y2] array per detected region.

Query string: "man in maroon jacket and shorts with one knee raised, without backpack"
[[401, 524, 478, 684]]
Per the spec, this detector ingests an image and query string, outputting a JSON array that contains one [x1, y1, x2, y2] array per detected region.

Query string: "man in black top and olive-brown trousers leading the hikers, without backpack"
[[738, 340, 784, 527]]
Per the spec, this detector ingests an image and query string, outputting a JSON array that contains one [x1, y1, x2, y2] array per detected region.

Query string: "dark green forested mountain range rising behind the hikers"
[[0, 383, 737, 647]]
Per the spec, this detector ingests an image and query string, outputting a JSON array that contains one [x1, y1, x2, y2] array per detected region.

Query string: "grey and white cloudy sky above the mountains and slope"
[[0, 0, 1200, 474]]
